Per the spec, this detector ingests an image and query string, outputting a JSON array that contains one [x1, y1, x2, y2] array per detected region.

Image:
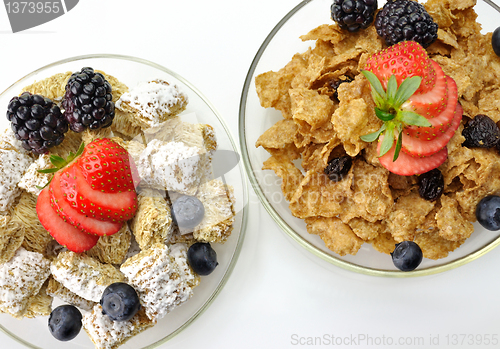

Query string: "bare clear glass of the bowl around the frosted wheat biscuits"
[[0, 55, 248, 349]]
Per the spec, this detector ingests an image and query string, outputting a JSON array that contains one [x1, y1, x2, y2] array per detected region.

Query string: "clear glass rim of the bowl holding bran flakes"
[[239, 0, 500, 278]]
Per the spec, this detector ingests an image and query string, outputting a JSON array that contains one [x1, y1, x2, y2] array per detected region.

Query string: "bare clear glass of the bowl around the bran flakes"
[[239, 0, 500, 277]]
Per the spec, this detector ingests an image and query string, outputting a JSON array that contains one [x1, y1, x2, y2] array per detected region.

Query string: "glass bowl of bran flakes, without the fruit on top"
[[240, 0, 500, 277]]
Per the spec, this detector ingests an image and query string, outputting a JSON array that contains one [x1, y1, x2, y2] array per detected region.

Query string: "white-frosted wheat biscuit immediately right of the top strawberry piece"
[[137, 139, 205, 195]]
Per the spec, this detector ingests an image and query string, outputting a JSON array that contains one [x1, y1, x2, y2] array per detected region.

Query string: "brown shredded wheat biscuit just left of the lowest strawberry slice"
[[12, 192, 55, 257]]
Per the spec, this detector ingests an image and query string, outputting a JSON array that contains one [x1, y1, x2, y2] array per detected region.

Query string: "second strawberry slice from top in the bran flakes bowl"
[[402, 59, 450, 120]]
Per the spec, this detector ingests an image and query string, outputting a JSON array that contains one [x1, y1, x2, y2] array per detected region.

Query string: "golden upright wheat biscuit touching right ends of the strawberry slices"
[[131, 188, 174, 250]]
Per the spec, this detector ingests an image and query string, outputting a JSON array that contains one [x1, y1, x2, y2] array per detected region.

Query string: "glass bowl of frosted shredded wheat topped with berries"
[[0, 55, 248, 348]]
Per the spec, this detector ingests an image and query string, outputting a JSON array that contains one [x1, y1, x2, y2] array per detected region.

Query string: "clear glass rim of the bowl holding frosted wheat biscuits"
[[0, 53, 248, 349]]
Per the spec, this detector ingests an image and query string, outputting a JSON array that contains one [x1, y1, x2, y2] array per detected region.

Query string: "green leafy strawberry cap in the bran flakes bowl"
[[360, 70, 432, 161]]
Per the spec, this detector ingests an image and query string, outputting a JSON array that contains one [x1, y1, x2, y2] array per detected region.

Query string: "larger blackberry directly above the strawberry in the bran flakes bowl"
[[375, 0, 438, 48]]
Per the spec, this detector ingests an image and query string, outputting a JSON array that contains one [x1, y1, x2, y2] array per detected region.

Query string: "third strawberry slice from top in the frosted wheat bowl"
[[49, 172, 122, 236]]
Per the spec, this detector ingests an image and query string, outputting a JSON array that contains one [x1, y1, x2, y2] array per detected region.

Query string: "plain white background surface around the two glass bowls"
[[0, 0, 500, 349]]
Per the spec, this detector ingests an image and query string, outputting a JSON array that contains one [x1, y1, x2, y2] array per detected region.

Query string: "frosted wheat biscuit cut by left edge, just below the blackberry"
[[0, 141, 33, 213]]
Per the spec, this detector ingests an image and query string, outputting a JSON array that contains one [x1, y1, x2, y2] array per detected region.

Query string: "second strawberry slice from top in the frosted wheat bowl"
[[61, 165, 137, 222]]
